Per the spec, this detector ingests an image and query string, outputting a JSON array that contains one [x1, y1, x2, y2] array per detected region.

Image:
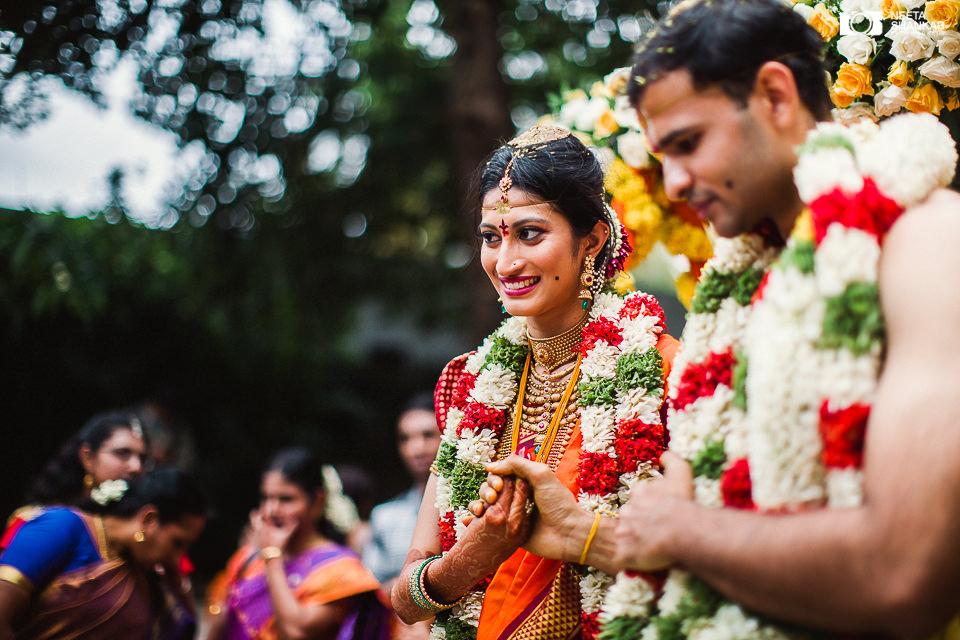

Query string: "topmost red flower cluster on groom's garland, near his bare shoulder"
[[810, 178, 903, 246]]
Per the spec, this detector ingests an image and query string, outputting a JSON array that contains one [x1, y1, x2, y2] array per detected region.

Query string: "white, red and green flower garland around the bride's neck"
[[431, 292, 665, 640]]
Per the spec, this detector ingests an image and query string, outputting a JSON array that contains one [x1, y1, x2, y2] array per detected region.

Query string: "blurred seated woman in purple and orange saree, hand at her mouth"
[[207, 448, 393, 640]]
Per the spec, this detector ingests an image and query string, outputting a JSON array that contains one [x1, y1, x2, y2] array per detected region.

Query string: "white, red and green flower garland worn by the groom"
[[601, 115, 957, 640]]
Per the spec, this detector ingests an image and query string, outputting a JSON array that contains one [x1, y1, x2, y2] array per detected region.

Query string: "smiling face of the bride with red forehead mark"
[[478, 189, 590, 337]]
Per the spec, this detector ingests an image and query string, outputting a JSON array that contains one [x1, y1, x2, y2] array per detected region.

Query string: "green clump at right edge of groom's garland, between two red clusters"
[[820, 282, 884, 356]]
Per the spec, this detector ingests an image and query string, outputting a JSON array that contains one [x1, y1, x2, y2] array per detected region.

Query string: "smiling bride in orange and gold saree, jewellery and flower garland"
[[392, 126, 676, 639]]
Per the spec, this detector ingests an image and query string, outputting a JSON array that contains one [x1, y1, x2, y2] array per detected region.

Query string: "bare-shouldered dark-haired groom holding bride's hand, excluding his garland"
[[481, 0, 960, 636]]
